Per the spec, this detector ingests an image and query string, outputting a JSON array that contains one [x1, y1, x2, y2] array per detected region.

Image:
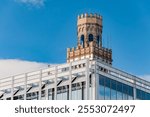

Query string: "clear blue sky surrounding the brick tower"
[[0, 0, 150, 75]]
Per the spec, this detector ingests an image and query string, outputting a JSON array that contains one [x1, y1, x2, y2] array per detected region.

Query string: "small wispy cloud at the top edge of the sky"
[[15, 0, 46, 7]]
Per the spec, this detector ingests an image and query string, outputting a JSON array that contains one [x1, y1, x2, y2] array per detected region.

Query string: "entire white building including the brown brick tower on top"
[[0, 14, 150, 100]]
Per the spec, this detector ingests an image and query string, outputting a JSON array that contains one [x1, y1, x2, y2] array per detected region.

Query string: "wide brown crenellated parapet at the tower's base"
[[67, 43, 112, 65]]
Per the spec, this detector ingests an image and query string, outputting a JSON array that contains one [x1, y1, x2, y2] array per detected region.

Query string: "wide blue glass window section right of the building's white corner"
[[99, 75, 133, 100]]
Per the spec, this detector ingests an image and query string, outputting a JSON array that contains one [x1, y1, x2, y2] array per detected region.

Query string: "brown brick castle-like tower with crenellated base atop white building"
[[67, 13, 112, 65]]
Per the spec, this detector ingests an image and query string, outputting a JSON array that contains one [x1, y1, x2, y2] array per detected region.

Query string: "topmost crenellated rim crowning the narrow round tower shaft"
[[78, 13, 102, 20]]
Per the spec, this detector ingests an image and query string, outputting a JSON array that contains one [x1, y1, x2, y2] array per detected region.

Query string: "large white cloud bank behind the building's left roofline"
[[0, 59, 48, 78]]
